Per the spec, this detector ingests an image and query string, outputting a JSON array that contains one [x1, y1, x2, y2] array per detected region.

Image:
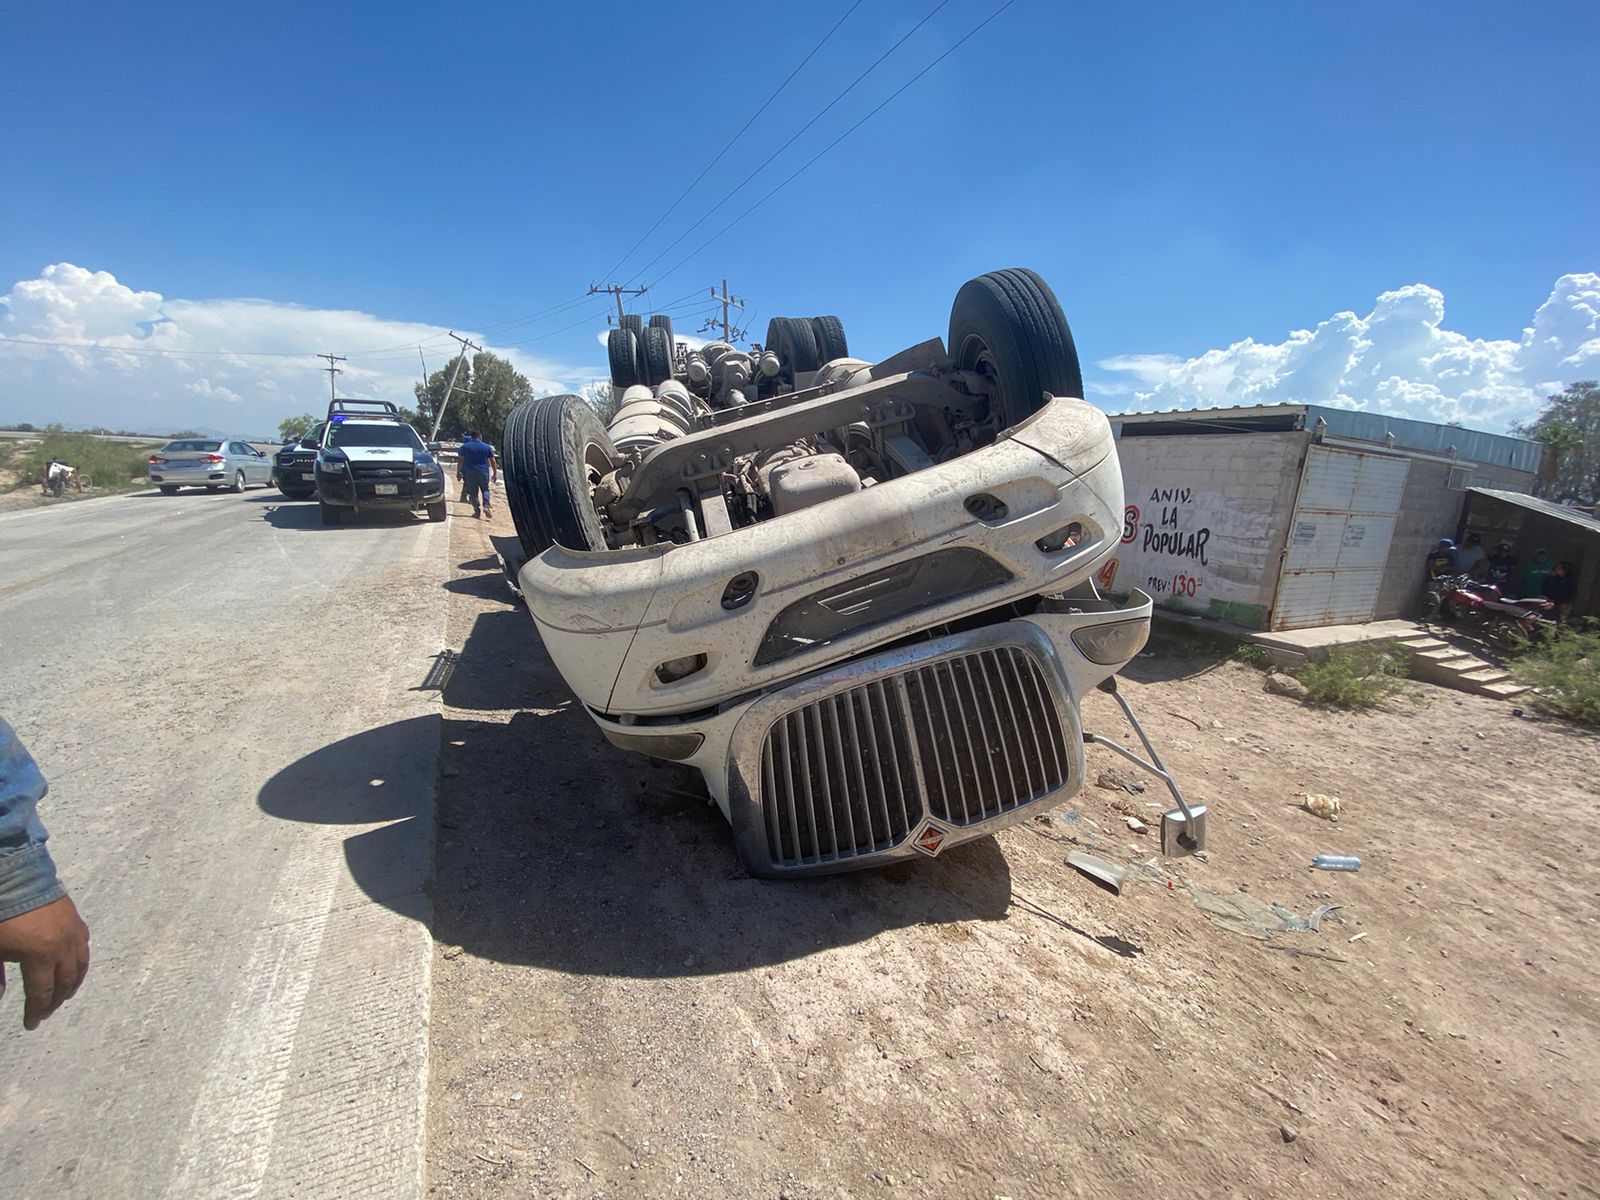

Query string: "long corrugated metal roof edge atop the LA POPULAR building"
[[1110, 405, 1544, 475]]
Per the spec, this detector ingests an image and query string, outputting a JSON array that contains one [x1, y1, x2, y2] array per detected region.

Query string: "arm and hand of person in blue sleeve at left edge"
[[0, 718, 90, 1029]]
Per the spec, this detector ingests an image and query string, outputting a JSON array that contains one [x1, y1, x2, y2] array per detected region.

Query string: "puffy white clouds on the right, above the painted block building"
[[1090, 274, 1600, 430]]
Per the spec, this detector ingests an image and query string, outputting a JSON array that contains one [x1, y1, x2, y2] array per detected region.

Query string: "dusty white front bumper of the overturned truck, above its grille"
[[518, 398, 1123, 717]]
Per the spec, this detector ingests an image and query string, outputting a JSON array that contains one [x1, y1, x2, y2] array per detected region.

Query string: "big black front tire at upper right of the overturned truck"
[[947, 267, 1083, 432]]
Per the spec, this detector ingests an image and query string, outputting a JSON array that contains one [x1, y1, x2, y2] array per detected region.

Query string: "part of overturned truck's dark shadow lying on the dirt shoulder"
[[432, 694, 1011, 978]]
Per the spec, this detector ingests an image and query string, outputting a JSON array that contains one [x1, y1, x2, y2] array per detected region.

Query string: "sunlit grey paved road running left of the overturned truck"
[[0, 490, 448, 1197]]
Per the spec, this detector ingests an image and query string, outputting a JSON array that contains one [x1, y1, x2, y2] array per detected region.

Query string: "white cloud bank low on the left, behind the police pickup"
[[0, 262, 595, 435]]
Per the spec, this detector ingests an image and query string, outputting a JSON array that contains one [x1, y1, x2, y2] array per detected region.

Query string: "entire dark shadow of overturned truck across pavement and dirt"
[[259, 611, 1011, 978]]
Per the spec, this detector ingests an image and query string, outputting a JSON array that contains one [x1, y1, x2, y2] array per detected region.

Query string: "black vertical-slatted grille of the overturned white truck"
[[762, 646, 1072, 867]]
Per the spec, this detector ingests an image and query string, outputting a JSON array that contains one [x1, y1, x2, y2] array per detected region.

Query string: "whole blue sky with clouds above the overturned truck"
[[0, 0, 1600, 429]]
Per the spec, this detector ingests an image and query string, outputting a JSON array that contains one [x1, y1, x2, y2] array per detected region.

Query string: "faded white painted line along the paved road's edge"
[[166, 840, 344, 1200]]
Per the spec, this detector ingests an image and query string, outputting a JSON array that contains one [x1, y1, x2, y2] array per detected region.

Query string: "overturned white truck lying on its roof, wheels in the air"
[[502, 270, 1205, 877]]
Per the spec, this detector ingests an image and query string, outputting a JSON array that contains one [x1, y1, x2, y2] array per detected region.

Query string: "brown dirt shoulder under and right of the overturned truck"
[[429, 521, 1600, 1200]]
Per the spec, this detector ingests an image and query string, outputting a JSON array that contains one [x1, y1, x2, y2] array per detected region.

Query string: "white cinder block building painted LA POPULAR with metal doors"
[[1101, 405, 1542, 629]]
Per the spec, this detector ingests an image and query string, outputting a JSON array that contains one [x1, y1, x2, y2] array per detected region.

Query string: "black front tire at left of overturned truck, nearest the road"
[[501, 395, 616, 558]]
